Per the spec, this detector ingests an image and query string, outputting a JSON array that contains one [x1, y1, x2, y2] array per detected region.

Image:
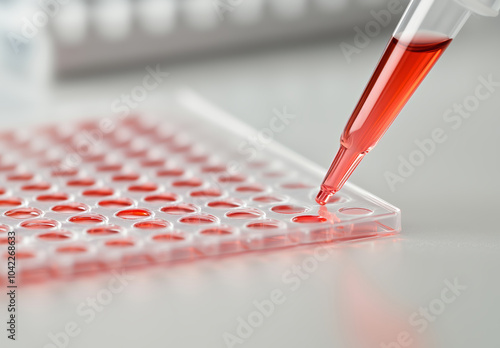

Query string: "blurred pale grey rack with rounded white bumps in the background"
[[49, 0, 407, 75]]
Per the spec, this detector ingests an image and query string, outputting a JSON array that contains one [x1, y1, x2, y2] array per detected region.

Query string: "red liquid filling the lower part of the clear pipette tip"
[[316, 34, 451, 204]]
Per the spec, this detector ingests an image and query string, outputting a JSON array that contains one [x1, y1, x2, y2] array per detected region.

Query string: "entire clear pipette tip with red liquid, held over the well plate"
[[316, 0, 500, 204]]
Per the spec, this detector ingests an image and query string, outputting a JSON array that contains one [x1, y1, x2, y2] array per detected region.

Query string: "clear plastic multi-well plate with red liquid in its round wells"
[[0, 91, 400, 282]]
